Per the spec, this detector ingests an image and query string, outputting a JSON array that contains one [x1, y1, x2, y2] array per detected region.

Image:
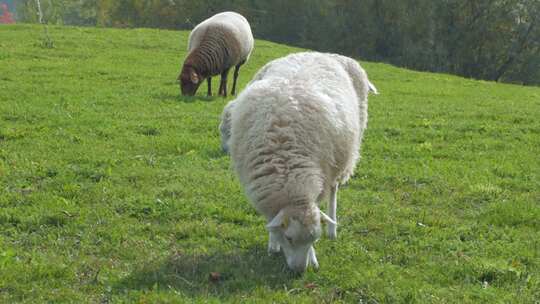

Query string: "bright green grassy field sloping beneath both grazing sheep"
[[0, 25, 540, 303]]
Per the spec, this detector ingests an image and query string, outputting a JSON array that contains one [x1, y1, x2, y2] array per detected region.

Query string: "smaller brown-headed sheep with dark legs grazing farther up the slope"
[[178, 12, 253, 96]]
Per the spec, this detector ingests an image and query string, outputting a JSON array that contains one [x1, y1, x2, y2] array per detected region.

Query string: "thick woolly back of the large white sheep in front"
[[230, 55, 360, 214]]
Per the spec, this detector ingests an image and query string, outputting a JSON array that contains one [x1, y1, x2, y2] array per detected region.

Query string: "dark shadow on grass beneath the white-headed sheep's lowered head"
[[113, 247, 298, 299]]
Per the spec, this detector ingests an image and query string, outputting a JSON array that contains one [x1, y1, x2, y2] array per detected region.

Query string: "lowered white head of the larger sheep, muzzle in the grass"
[[266, 205, 335, 272]]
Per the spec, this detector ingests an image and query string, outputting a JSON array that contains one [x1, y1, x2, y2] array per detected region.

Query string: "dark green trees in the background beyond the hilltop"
[[17, 0, 540, 85]]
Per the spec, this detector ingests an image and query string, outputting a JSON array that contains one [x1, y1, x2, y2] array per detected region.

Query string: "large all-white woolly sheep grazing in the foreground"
[[220, 52, 376, 272]]
